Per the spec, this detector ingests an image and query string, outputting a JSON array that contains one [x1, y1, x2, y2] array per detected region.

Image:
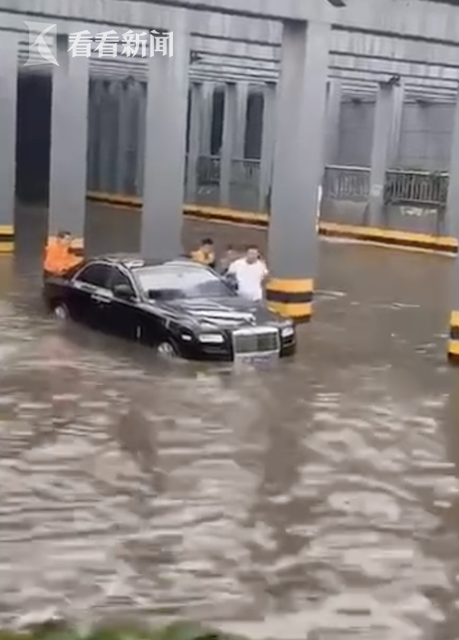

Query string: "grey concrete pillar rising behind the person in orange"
[[48, 34, 89, 238]]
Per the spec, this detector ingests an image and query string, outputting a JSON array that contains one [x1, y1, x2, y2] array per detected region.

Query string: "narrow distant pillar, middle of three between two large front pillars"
[[220, 83, 237, 207]]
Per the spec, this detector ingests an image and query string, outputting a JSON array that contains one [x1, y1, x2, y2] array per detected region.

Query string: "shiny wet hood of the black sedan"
[[156, 297, 280, 329]]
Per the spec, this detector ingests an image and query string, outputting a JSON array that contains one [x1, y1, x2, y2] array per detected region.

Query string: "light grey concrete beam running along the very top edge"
[[0, 0, 459, 48]]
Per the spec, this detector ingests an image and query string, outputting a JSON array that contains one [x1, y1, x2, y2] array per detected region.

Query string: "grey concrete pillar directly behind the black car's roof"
[[140, 10, 190, 259]]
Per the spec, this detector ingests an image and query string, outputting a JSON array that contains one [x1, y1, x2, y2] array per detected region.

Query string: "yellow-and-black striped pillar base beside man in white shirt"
[[266, 278, 314, 322]]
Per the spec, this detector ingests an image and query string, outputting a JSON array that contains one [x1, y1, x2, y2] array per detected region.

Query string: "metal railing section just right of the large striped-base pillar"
[[323, 166, 370, 202]]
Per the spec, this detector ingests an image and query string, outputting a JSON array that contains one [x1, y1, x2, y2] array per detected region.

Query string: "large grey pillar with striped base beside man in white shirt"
[[267, 21, 331, 321]]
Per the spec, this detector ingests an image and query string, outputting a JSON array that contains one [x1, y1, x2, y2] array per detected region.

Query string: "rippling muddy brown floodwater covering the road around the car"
[[0, 204, 459, 640]]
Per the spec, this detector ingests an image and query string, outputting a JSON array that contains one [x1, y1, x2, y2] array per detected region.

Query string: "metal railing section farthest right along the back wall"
[[384, 170, 449, 206]]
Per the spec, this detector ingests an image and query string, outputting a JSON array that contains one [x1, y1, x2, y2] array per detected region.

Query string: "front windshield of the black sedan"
[[136, 265, 236, 300]]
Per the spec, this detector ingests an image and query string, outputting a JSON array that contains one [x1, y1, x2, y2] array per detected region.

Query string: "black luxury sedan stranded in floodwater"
[[44, 255, 296, 361]]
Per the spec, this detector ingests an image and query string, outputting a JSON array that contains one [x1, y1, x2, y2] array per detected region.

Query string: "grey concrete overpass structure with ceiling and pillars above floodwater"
[[0, 0, 459, 355]]
